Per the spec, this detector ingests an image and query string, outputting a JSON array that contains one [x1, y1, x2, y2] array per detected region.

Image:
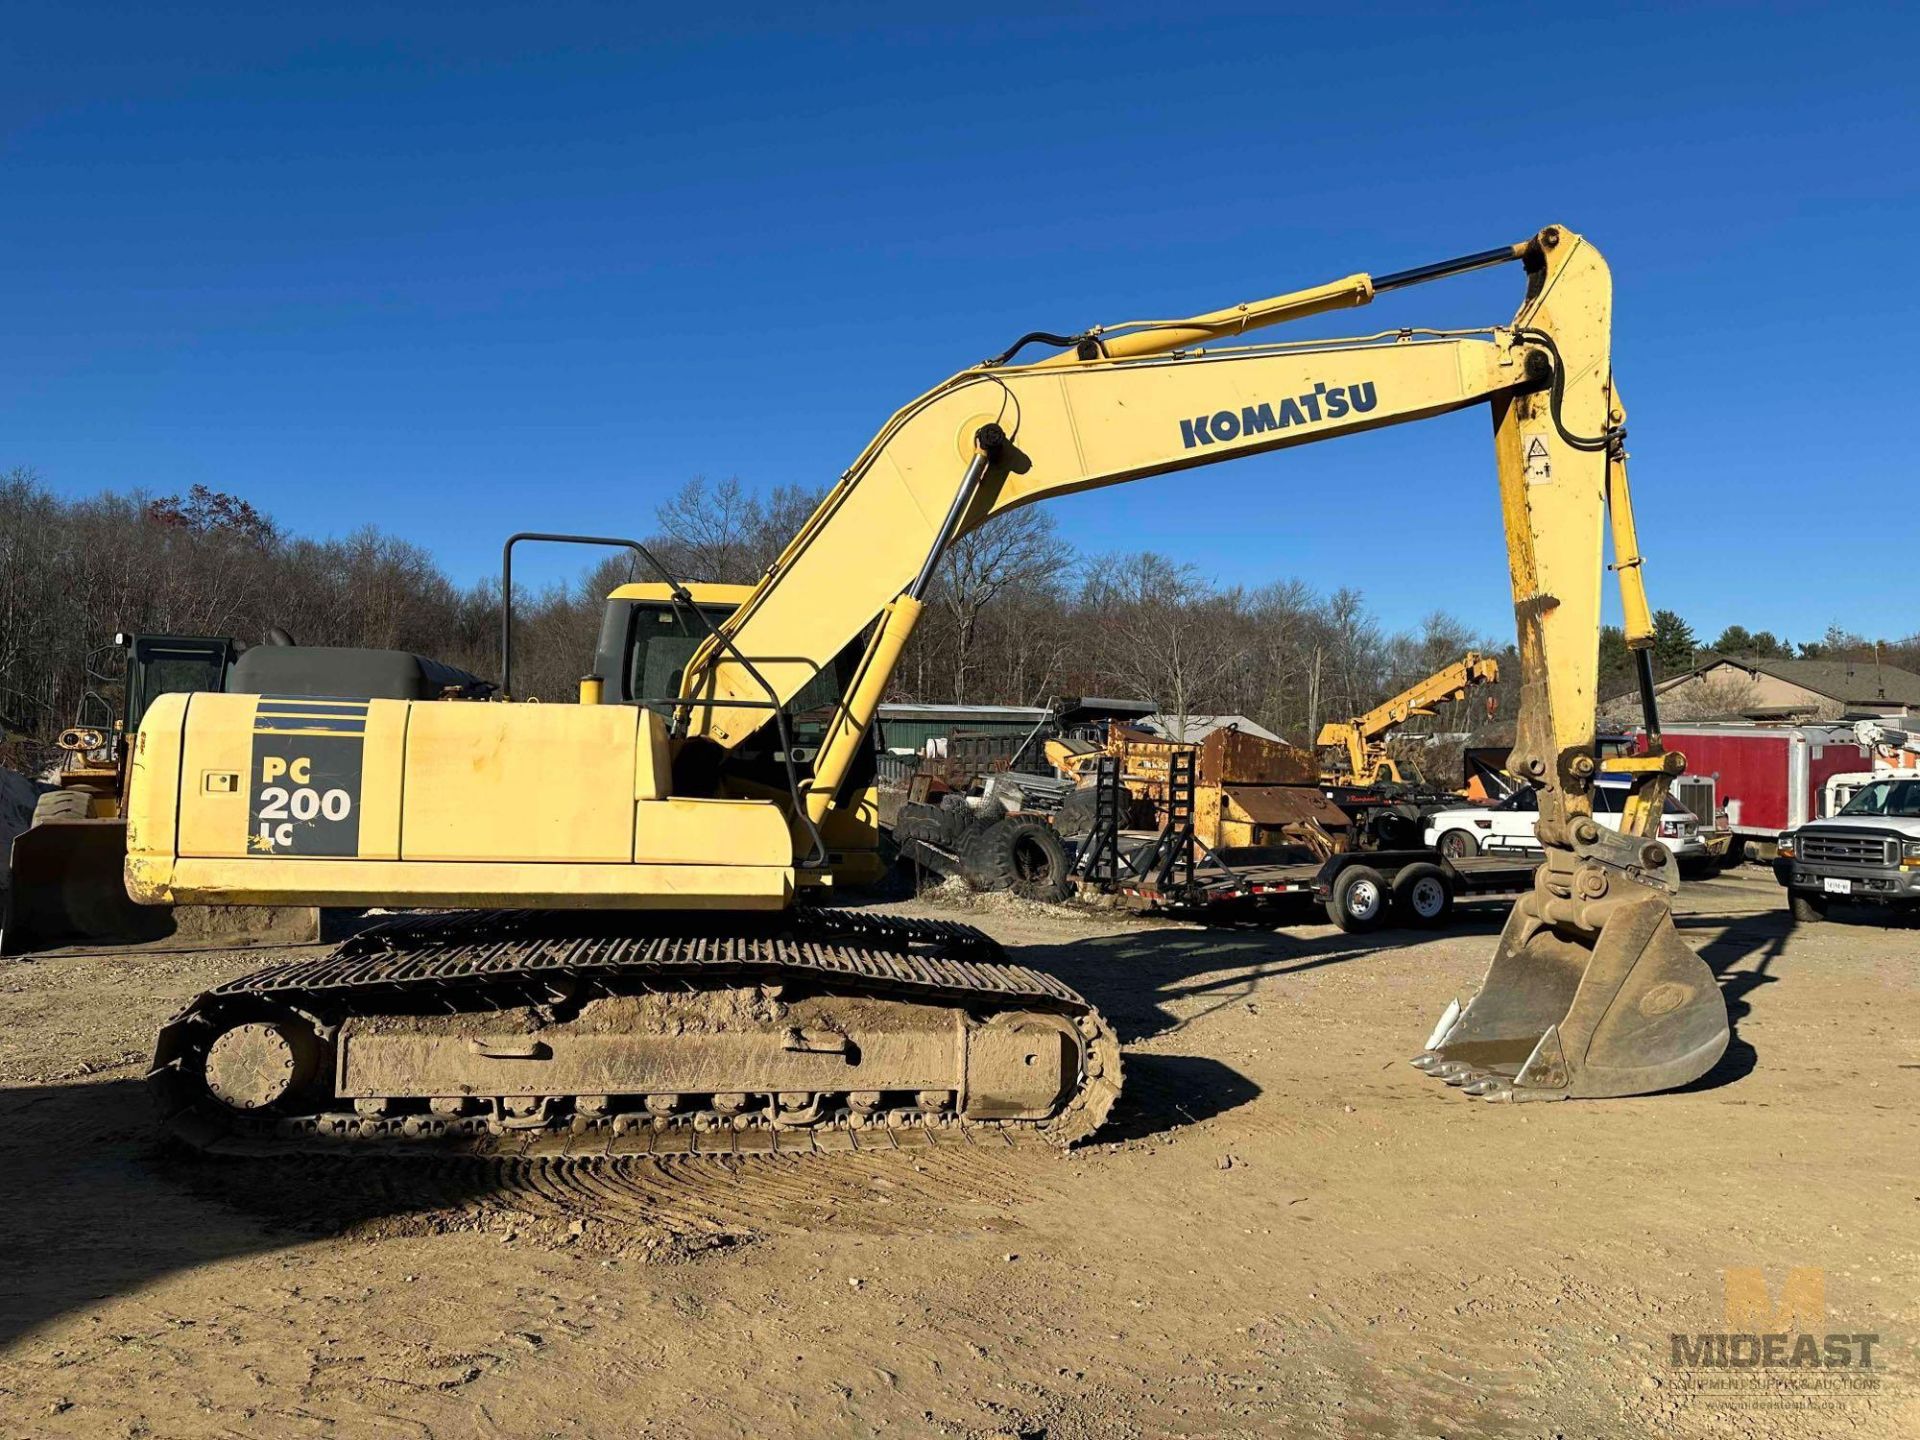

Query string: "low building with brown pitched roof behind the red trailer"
[[1599, 655, 1920, 722]]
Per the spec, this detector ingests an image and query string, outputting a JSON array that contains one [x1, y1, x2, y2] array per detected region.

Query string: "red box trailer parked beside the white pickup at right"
[[1636, 722, 1874, 860]]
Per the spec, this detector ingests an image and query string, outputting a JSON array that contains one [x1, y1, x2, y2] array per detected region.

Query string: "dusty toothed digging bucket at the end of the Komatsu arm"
[[1413, 889, 1728, 1100]]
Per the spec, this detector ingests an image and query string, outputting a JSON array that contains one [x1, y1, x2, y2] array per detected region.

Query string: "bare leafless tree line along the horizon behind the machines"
[[11, 470, 1920, 779]]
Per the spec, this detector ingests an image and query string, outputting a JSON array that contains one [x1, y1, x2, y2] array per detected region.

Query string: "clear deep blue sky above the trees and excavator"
[[0, 4, 1920, 639]]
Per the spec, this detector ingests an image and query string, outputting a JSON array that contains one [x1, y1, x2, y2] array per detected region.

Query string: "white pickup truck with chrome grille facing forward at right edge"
[[1774, 776, 1920, 920]]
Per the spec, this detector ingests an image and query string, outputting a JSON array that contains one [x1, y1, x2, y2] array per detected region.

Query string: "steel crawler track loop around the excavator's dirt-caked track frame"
[[148, 910, 1121, 1158]]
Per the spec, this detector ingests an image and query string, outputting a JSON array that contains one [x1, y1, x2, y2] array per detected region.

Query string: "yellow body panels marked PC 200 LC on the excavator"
[[127, 695, 795, 910]]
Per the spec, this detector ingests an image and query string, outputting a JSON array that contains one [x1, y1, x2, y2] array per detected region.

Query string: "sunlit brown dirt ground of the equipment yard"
[[0, 872, 1920, 1440]]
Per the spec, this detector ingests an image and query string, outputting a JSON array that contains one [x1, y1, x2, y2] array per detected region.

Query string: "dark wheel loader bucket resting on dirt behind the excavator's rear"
[[0, 818, 321, 954]]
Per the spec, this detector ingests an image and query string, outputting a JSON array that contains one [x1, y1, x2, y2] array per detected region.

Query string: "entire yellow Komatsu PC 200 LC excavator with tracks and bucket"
[[127, 227, 1728, 1156]]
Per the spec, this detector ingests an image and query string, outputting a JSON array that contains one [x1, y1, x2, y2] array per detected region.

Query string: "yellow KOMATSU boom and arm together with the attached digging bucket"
[[676, 227, 1728, 1098]]
